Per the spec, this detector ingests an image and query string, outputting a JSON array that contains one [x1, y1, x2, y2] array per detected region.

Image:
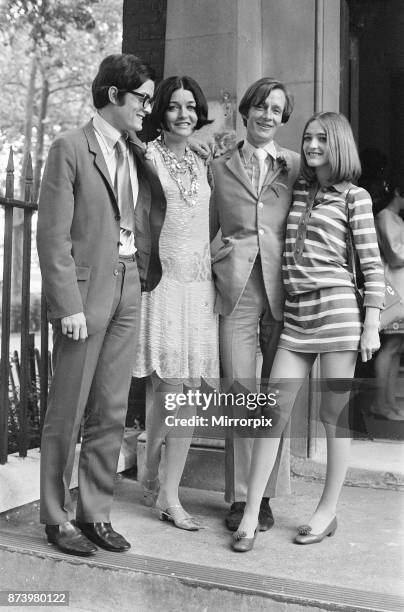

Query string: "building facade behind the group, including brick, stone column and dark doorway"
[[123, 0, 404, 455]]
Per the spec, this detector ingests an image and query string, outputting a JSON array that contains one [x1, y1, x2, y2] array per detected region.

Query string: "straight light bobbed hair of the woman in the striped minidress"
[[300, 112, 361, 185]]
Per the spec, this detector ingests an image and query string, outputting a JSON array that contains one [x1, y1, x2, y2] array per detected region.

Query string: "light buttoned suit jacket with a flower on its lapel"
[[211, 142, 300, 321]]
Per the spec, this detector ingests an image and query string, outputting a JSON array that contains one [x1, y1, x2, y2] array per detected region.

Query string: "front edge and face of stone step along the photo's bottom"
[[0, 531, 404, 612]]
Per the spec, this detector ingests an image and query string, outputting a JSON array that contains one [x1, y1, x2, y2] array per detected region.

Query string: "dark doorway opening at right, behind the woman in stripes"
[[340, 0, 404, 440]]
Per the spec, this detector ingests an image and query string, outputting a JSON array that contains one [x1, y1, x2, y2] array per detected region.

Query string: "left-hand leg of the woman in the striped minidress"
[[239, 349, 315, 538]]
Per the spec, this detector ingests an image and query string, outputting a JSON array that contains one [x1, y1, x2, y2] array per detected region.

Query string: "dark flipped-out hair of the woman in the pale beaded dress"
[[150, 76, 212, 131]]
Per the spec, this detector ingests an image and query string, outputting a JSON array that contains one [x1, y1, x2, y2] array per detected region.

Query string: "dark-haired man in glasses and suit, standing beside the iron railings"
[[37, 54, 166, 556]]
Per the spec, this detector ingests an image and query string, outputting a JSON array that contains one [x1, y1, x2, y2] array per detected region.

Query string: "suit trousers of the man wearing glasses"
[[40, 259, 141, 524]]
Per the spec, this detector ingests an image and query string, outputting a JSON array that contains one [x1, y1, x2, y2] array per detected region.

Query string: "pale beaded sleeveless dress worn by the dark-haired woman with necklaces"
[[133, 144, 219, 387]]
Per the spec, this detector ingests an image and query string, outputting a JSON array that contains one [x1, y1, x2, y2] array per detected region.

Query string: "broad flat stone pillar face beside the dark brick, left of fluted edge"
[[164, 0, 262, 146]]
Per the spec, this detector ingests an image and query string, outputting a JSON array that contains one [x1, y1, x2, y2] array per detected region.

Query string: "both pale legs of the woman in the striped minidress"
[[239, 349, 357, 537]]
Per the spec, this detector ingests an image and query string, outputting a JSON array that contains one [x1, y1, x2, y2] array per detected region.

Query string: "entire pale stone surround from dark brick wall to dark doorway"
[[164, 0, 340, 149]]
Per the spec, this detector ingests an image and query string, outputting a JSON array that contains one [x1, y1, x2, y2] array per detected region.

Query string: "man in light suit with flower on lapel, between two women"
[[211, 77, 300, 531]]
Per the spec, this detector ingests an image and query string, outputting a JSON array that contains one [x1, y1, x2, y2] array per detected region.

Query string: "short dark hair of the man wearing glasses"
[[91, 53, 154, 109]]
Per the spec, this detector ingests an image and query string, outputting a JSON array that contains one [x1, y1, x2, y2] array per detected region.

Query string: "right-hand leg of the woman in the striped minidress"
[[308, 351, 357, 534]]
